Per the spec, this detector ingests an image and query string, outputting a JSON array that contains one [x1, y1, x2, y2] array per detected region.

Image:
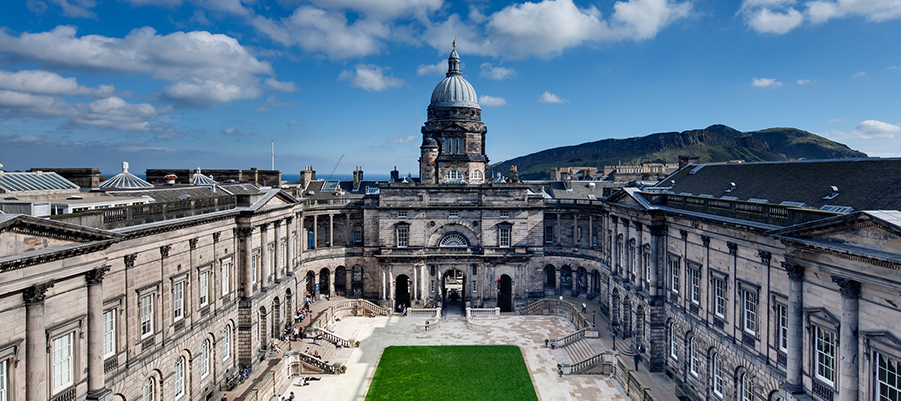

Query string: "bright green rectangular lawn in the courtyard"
[[366, 345, 538, 401]]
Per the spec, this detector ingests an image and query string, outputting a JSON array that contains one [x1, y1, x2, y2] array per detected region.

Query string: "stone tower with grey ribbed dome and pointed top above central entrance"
[[419, 44, 488, 184]]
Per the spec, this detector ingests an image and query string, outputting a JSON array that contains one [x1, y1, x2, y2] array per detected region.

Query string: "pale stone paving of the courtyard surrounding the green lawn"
[[274, 315, 625, 401]]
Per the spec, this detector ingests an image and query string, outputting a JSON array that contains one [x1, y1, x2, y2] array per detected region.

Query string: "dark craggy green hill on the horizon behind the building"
[[490, 125, 867, 179]]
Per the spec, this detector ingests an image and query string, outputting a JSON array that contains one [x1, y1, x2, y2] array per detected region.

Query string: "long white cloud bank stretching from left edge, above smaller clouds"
[[0, 26, 287, 105]]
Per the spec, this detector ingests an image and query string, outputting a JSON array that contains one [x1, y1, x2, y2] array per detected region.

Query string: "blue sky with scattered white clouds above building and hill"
[[0, 0, 901, 178]]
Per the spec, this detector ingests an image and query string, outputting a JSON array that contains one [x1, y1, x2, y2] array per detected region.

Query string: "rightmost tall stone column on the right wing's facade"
[[832, 276, 860, 401]]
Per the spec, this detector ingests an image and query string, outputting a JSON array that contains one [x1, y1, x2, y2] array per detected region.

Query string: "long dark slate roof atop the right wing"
[[656, 158, 901, 210]]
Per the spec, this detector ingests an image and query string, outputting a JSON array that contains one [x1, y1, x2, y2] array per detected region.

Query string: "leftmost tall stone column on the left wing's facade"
[[22, 282, 53, 400]]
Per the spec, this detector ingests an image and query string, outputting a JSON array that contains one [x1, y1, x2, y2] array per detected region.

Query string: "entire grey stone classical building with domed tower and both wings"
[[0, 47, 901, 401]]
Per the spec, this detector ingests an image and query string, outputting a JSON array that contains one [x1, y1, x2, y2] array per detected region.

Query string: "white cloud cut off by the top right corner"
[[738, 0, 901, 35]]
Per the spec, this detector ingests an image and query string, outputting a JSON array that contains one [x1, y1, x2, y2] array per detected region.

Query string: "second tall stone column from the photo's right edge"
[[782, 262, 804, 394]]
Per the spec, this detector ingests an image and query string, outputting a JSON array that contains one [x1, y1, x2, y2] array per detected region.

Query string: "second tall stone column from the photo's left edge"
[[85, 266, 110, 400]]
